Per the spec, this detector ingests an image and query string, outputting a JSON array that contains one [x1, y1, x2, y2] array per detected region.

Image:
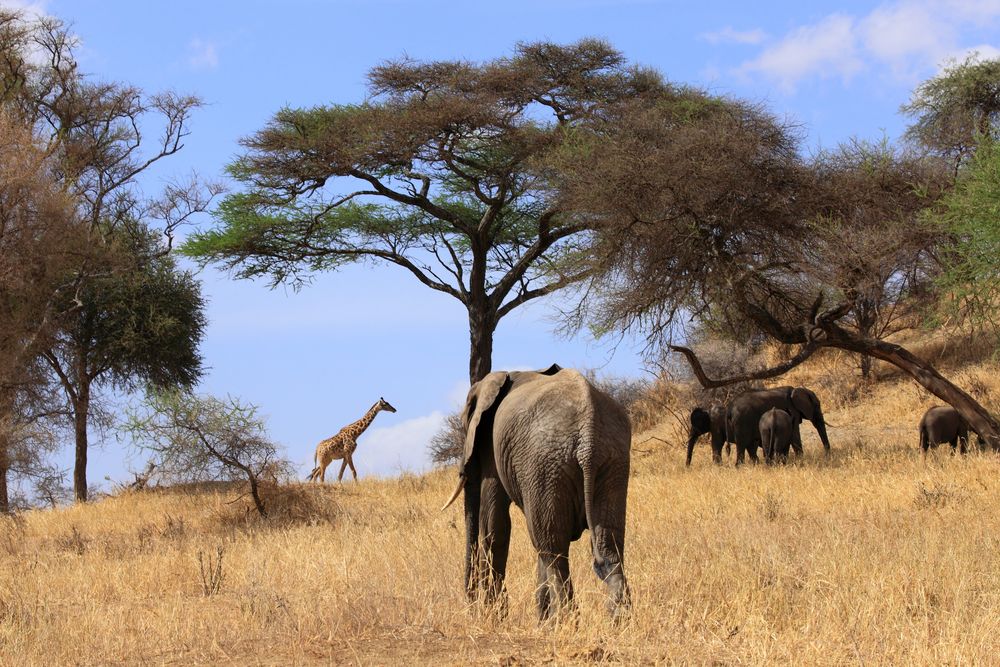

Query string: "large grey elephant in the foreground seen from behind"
[[445, 365, 632, 619]]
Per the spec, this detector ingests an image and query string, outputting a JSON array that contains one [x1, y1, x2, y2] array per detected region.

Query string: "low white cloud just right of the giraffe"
[[356, 410, 445, 479]]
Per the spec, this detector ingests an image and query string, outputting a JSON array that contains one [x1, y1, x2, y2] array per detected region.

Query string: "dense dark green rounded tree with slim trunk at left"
[[43, 233, 206, 501]]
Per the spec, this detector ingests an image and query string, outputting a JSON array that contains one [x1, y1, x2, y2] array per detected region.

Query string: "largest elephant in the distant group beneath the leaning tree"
[[726, 387, 830, 465]]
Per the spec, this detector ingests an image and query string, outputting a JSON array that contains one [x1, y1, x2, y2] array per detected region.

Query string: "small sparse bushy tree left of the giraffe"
[[126, 391, 291, 518]]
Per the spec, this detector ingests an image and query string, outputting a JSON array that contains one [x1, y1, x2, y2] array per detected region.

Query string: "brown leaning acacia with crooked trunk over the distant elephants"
[[562, 94, 1000, 448]]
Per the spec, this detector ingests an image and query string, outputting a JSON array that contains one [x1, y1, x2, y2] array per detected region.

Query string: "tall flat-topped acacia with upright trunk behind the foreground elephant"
[[183, 40, 663, 382]]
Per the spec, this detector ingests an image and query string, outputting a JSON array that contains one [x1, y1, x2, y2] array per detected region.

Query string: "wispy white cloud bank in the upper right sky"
[[732, 0, 1000, 92]]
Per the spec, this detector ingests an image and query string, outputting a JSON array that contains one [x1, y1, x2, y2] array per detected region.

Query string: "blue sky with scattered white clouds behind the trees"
[[0, 0, 1000, 488]]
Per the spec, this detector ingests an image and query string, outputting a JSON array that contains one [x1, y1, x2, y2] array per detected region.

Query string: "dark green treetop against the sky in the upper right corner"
[[902, 54, 1000, 171]]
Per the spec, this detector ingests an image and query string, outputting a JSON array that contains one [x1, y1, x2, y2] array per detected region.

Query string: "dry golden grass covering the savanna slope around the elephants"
[[0, 332, 1000, 665]]
